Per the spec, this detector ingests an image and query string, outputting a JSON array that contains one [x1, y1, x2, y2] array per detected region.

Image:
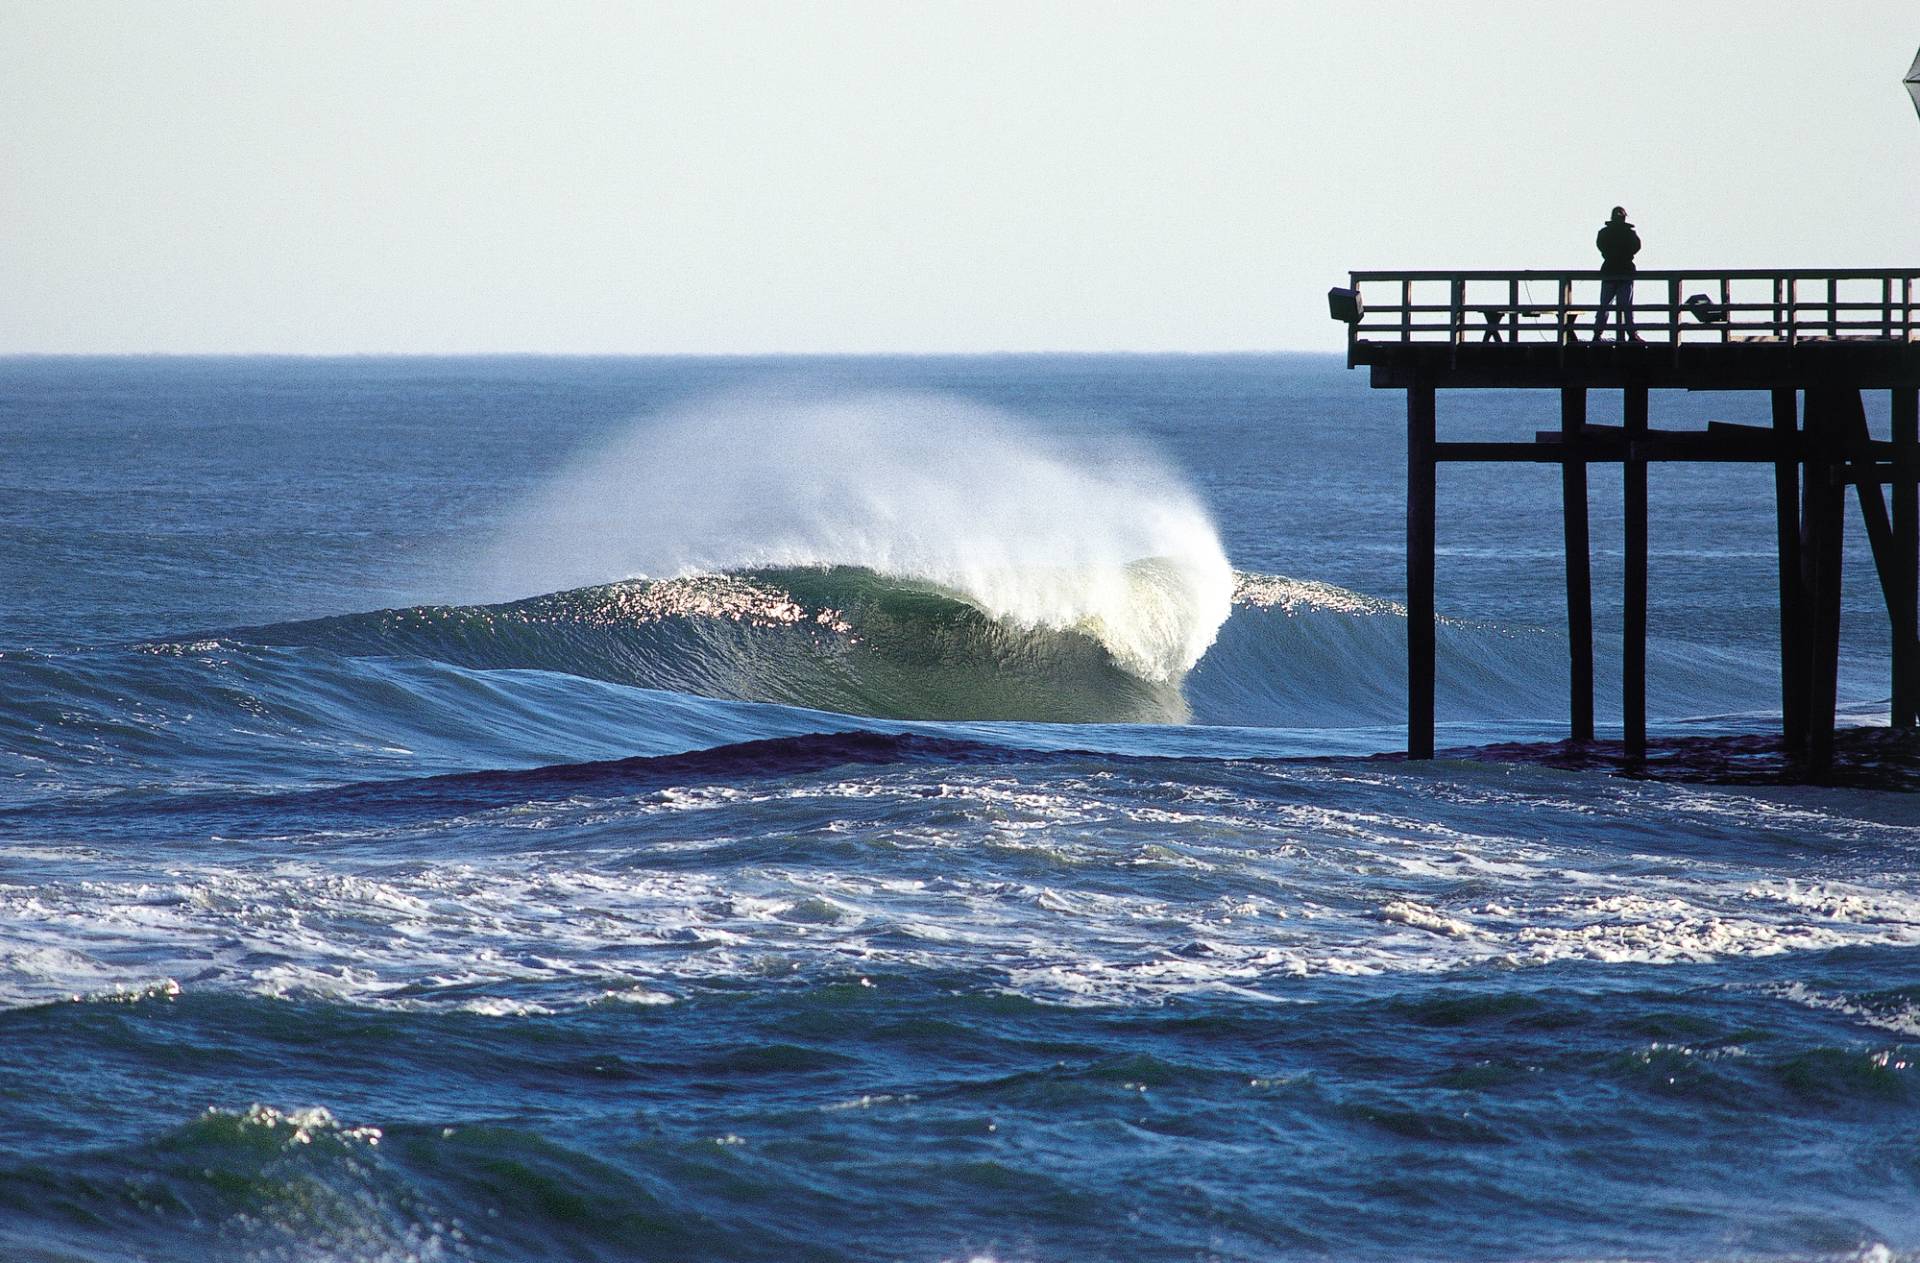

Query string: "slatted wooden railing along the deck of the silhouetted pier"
[[1336, 269, 1920, 349]]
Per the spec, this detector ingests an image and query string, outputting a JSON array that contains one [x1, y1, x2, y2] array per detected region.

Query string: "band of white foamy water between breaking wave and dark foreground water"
[[15, 762, 1920, 1005]]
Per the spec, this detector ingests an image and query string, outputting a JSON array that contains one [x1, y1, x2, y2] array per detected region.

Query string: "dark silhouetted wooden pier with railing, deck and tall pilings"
[[1332, 269, 1920, 774]]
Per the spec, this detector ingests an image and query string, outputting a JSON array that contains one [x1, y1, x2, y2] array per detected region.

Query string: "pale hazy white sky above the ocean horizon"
[[0, 0, 1920, 353]]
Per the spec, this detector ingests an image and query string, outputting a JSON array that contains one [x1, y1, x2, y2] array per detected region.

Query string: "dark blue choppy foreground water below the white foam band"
[[15, 963, 1920, 1261]]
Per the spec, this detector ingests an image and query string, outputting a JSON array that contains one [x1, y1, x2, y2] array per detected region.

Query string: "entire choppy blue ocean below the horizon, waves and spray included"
[[0, 355, 1920, 1261]]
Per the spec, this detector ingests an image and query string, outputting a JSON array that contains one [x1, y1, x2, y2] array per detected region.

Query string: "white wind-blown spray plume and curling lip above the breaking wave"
[[480, 395, 1233, 681]]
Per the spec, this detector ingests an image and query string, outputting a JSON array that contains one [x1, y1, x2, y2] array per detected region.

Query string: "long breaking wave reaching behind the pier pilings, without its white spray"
[[240, 562, 1770, 727]]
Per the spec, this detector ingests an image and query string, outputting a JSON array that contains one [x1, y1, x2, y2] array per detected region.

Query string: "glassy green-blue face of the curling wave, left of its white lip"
[[242, 566, 1188, 724]]
